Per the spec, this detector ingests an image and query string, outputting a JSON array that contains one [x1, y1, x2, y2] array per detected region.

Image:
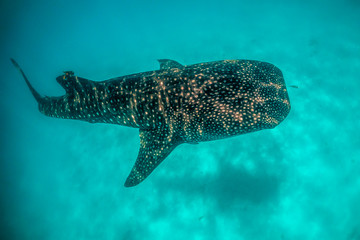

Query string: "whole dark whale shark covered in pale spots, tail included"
[[12, 59, 290, 187]]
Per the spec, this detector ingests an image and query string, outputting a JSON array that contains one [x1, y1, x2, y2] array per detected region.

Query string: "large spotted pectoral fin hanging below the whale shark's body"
[[124, 128, 182, 187]]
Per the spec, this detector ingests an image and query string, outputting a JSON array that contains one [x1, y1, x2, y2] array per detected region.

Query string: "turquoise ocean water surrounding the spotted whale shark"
[[0, 0, 360, 240]]
